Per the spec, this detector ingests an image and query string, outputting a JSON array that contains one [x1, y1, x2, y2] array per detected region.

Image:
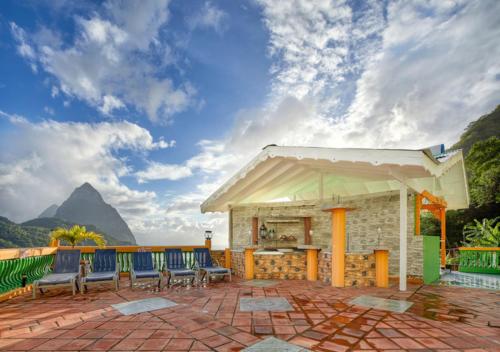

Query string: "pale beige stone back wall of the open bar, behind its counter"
[[231, 191, 423, 276]]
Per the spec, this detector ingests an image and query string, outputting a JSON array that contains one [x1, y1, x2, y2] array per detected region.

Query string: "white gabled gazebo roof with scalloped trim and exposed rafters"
[[201, 145, 469, 212]]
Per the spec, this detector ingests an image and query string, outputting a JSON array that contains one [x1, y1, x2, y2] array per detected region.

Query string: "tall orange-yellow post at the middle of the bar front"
[[332, 208, 346, 287]]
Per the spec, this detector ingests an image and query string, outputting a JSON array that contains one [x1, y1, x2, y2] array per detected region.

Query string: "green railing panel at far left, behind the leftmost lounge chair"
[[0, 255, 54, 294]]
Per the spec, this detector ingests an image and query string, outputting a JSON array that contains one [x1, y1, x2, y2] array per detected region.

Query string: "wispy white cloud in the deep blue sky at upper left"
[[11, 0, 196, 123]]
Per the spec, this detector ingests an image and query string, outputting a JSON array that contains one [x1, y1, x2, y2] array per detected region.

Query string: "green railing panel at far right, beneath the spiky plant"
[[458, 249, 500, 274]]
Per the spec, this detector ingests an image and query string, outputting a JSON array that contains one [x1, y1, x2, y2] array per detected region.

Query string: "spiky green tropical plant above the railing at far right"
[[464, 217, 500, 247]]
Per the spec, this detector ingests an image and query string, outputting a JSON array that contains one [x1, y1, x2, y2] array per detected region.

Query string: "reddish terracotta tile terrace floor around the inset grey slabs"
[[0, 279, 500, 351]]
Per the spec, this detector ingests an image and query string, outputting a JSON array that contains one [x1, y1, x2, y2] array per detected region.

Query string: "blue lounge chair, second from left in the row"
[[80, 249, 120, 293]]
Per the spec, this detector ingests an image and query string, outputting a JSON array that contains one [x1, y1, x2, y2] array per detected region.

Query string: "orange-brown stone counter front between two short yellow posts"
[[253, 252, 307, 280]]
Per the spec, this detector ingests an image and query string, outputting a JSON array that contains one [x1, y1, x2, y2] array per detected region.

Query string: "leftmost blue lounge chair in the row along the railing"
[[33, 249, 80, 298]]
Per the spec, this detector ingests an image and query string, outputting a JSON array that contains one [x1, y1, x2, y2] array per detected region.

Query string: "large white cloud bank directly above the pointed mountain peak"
[[0, 111, 170, 231]]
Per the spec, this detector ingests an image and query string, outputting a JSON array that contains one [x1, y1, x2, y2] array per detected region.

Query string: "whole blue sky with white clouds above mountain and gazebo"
[[0, 0, 500, 246]]
